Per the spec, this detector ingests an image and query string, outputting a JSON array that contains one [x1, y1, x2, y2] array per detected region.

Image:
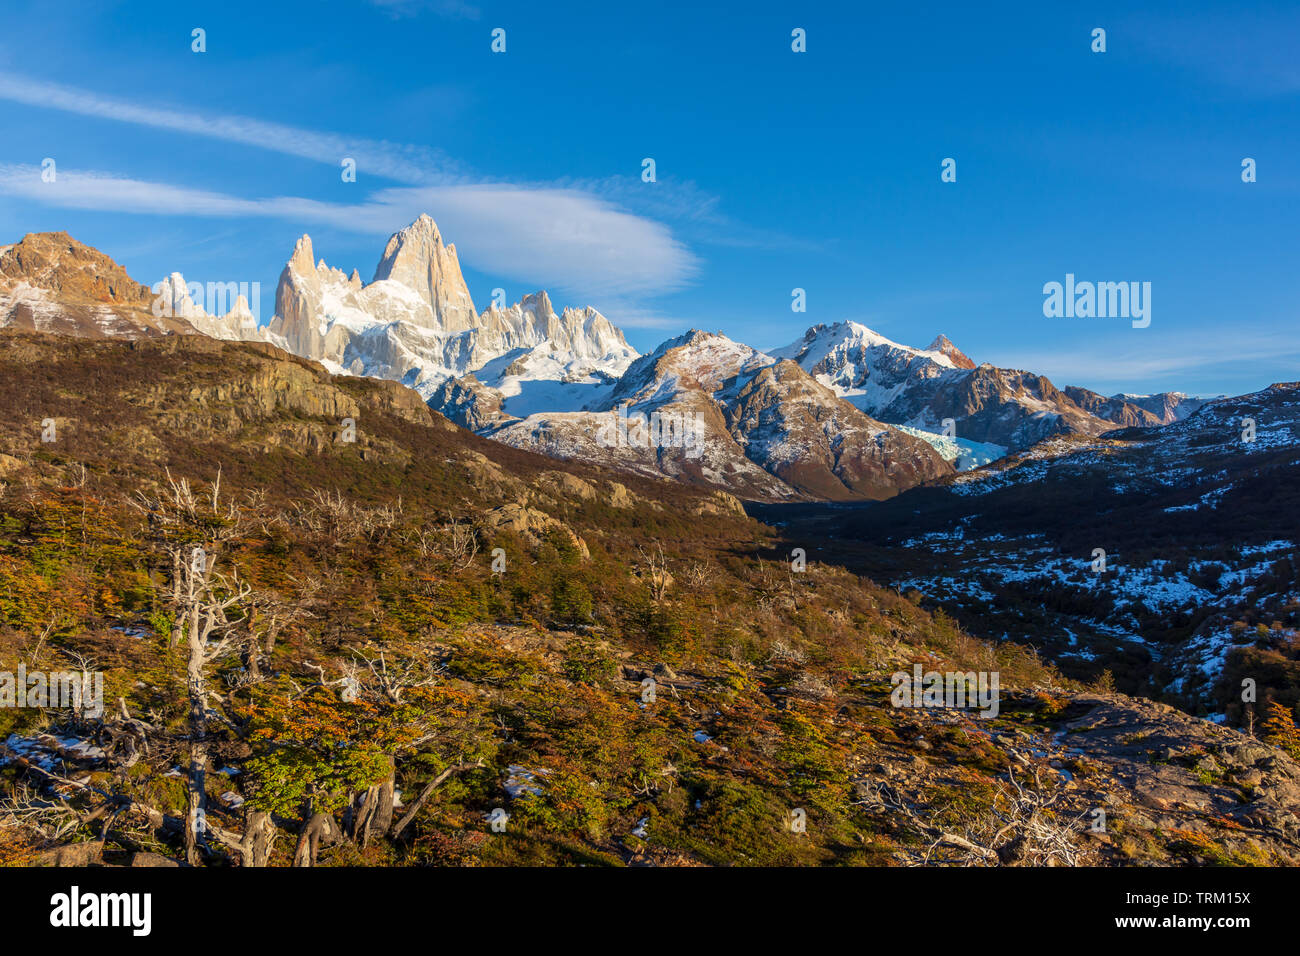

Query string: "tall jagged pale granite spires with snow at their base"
[[261, 216, 636, 400]]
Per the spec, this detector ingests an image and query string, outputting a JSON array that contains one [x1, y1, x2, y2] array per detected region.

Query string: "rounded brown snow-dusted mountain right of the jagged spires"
[[490, 332, 952, 499]]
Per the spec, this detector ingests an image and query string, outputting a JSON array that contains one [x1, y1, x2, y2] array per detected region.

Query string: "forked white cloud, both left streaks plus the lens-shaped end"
[[0, 72, 722, 295]]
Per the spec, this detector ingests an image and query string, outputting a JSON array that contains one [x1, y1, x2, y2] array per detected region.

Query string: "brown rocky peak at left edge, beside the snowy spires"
[[0, 233, 194, 338]]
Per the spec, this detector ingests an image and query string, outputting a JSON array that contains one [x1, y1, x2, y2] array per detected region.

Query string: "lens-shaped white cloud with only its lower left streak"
[[0, 165, 698, 295]]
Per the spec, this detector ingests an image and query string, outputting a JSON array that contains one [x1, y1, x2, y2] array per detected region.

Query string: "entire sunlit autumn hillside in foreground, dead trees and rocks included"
[[0, 330, 1300, 866]]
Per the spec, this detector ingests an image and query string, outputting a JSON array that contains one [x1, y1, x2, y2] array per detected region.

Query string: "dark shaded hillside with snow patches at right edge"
[[762, 382, 1300, 724]]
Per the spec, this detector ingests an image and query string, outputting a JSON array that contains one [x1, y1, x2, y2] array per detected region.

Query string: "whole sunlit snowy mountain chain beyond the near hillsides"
[[0, 216, 1200, 501]]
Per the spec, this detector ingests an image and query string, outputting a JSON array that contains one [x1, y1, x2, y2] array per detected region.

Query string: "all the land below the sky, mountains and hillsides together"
[[0, 217, 1300, 866]]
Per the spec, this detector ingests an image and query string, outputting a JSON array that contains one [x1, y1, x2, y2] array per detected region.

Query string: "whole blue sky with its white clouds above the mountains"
[[0, 0, 1300, 394]]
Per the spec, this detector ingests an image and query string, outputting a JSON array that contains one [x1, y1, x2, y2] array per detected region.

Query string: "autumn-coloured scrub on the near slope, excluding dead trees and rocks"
[[0, 333, 1291, 865]]
